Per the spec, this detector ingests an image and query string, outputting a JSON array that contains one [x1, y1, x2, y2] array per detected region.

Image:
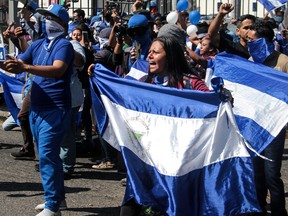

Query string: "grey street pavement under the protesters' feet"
[[0, 101, 288, 216]]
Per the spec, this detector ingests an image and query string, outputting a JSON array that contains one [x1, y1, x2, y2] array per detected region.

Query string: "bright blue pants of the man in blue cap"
[[29, 108, 71, 211]]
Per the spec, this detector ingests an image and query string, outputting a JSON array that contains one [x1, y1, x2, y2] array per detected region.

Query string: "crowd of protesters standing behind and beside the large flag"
[[0, 0, 288, 216]]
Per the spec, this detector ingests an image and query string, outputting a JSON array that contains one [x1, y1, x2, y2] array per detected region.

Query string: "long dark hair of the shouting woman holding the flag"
[[147, 36, 190, 88]]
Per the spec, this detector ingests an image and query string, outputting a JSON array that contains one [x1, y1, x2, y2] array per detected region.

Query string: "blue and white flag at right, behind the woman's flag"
[[214, 53, 288, 152]]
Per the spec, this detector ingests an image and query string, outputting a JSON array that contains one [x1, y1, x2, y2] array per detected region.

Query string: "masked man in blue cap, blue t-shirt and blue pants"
[[2, 4, 74, 216]]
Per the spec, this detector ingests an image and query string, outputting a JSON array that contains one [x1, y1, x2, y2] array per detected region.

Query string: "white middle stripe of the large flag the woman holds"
[[101, 95, 250, 176]]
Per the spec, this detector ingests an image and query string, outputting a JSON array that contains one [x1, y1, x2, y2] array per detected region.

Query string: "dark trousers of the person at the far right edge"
[[254, 129, 287, 216]]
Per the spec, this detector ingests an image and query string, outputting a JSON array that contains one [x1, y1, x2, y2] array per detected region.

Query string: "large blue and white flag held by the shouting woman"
[[90, 64, 259, 216]]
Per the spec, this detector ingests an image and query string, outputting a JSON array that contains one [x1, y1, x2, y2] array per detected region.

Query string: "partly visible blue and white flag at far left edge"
[[0, 71, 24, 125]]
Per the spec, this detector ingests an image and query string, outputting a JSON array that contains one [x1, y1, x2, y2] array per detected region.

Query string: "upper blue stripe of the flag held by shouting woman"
[[92, 64, 220, 118]]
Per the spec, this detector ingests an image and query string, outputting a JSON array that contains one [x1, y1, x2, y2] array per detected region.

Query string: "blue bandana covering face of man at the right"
[[247, 38, 274, 63]]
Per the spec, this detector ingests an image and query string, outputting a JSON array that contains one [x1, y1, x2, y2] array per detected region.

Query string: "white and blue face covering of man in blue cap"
[[42, 19, 64, 41]]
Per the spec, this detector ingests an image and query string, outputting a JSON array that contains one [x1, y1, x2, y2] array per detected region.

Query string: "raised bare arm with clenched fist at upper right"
[[208, 3, 234, 46]]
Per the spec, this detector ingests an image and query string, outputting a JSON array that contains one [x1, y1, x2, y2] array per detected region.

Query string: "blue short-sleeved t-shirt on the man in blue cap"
[[19, 37, 74, 110]]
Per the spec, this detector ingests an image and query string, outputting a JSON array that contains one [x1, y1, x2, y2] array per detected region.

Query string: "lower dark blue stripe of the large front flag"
[[122, 148, 259, 216]]
